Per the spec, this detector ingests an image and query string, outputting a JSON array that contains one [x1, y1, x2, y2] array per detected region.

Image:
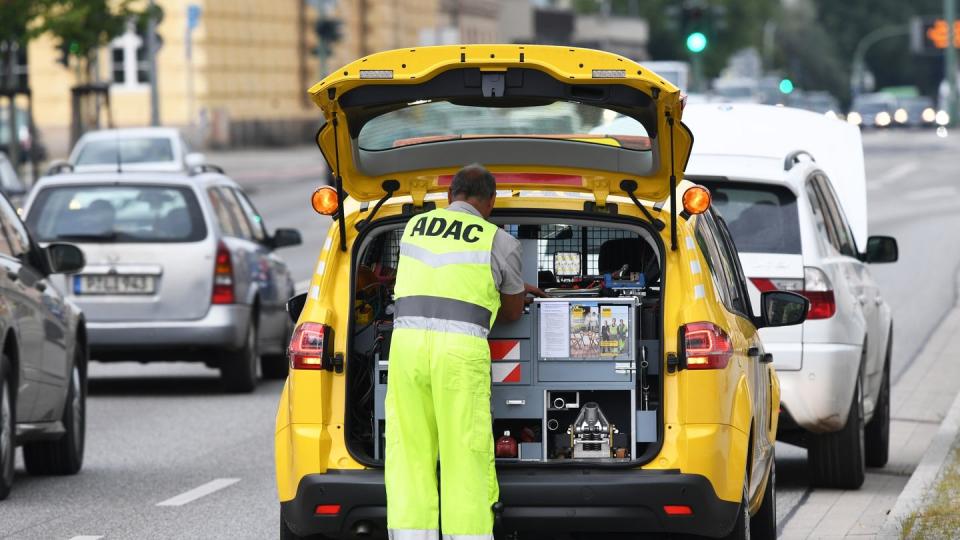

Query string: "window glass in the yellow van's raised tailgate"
[[358, 101, 650, 150]]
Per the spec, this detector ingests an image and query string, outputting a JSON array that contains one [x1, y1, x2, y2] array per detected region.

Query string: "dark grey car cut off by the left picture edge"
[[0, 192, 87, 499]]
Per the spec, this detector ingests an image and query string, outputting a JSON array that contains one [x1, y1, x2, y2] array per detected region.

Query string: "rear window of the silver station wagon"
[[26, 185, 207, 243]]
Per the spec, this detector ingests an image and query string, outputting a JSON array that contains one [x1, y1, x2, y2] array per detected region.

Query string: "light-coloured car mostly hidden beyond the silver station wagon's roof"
[[68, 127, 206, 172]]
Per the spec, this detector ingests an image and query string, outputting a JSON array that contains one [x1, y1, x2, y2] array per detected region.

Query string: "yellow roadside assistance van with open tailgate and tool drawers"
[[276, 45, 807, 538]]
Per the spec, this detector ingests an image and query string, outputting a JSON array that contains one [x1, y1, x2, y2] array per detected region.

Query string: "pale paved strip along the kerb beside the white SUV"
[[781, 276, 960, 539]]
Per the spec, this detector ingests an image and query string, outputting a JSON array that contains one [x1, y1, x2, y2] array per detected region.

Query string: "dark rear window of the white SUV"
[[703, 182, 801, 255]]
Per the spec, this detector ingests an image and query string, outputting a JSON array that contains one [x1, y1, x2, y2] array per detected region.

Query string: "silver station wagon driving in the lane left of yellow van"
[[24, 165, 301, 392]]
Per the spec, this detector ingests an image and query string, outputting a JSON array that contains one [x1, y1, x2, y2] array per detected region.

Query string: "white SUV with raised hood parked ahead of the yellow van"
[[683, 104, 897, 489]]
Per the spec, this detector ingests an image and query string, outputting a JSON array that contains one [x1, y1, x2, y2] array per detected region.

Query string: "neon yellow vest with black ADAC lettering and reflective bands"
[[394, 209, 500, 339]]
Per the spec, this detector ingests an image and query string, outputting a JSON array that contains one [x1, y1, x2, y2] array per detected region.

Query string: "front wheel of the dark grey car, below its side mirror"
[[23, 360, 87, 476]]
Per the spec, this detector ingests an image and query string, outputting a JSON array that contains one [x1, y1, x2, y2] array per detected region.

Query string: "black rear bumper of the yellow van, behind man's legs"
[[280, 468, 739, 539]]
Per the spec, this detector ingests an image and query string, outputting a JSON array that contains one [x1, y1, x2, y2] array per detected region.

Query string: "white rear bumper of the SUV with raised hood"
[[777, 343, 862, 433]]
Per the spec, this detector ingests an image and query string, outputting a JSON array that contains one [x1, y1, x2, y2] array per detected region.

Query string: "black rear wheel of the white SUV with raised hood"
[[807, 378, 866, 489]]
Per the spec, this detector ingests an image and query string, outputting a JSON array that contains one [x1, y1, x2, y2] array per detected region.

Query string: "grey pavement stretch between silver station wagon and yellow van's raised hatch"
[[204, 145, 327, 187]]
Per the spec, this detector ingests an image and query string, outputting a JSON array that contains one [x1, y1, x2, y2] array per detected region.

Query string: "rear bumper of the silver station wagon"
[[87, 304, 251, 360]]
